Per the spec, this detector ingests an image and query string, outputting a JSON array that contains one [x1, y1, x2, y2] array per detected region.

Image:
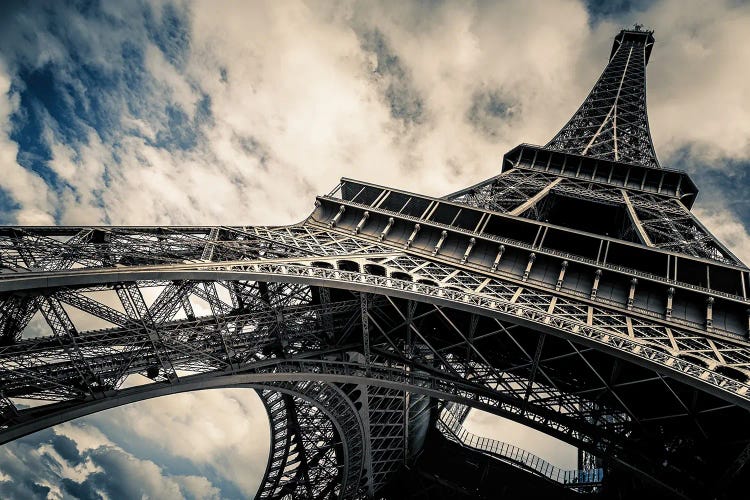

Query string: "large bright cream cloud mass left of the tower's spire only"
[[0, 2, 586, 224]]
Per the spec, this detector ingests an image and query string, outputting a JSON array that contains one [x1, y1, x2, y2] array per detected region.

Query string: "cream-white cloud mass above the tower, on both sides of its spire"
[[0, 0, 750, 234]]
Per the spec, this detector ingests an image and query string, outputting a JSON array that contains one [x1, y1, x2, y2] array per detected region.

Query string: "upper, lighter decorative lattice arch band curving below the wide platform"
[[0, 262, 750, 409]]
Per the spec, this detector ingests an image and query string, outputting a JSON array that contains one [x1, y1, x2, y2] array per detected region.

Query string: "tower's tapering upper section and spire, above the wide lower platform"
[[448, 25, 740, 266]]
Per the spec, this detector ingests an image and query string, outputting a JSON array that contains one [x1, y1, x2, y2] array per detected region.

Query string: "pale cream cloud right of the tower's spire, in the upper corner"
[[644, 0, 750, 162]]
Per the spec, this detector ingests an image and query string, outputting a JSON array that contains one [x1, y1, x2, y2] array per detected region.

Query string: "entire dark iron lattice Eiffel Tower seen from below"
[[0, 25, 750, 498]]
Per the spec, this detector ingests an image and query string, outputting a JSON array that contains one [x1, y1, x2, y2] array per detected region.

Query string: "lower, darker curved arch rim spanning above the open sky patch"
[[0, 360, 656, 464]]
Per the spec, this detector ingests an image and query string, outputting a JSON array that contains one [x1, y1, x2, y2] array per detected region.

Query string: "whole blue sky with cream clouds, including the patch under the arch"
[[0, 0, 750, 498]]
